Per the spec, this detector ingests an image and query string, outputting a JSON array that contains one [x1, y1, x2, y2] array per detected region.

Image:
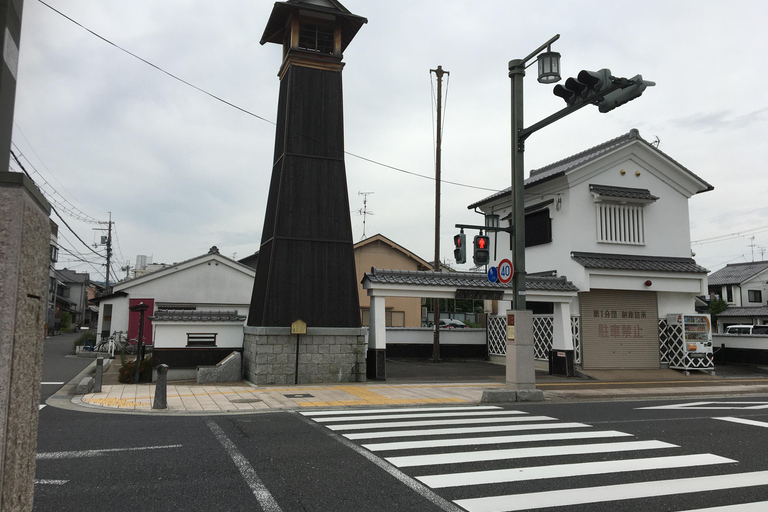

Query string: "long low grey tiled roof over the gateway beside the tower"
[[365, 268, 579, 292]]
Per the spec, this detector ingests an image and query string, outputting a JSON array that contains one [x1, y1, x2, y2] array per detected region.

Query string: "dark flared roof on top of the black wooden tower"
[[260, 0, 368, 52]]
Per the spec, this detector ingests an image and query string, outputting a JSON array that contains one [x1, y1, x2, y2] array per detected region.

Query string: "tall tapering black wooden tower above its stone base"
[[248, 0, 367, 327]]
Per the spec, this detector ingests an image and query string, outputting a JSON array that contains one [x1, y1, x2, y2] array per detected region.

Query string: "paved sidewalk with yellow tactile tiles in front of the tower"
[[54, 360, 768, 414]]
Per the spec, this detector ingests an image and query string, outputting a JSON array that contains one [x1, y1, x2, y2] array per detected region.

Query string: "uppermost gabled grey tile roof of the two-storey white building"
[[467, 128, 714, 210]]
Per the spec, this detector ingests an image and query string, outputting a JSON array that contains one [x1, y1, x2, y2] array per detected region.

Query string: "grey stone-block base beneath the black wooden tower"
[[243, 326, 368, 386]]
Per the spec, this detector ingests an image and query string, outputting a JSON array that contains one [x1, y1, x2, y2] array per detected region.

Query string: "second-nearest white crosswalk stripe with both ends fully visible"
[[385, 441, 678, 468]]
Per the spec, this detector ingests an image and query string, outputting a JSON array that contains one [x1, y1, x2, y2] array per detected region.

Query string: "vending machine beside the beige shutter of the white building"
[[667, 314, 715, 373]]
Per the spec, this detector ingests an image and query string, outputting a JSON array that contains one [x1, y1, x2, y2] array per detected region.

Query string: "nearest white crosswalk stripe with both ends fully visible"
[[416, 453, 738, 489]]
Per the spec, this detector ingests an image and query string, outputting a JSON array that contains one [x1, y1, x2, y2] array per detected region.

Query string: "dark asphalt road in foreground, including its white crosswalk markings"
[[35, 397, 768, 512]]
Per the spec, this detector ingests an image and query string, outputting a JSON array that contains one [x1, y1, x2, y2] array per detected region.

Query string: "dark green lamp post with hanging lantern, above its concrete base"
[[509, 34, 560, 311]]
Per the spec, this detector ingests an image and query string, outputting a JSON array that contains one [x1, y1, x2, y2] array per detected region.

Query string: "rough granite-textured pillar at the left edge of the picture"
[[0, 171, 51, 512]]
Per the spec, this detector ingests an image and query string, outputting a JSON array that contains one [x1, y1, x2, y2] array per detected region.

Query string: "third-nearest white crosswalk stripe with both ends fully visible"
[[362, 430, 632, 452]]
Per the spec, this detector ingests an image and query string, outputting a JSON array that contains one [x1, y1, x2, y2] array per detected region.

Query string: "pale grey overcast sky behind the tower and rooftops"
[[12, 0, 768, 278]]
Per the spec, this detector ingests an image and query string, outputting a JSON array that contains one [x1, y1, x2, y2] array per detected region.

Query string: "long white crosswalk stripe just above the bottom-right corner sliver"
[[454, 471, 768, 512]]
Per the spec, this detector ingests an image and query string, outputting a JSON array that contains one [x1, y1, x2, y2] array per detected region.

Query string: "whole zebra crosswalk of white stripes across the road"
[[301, 405, 768, 512]]
